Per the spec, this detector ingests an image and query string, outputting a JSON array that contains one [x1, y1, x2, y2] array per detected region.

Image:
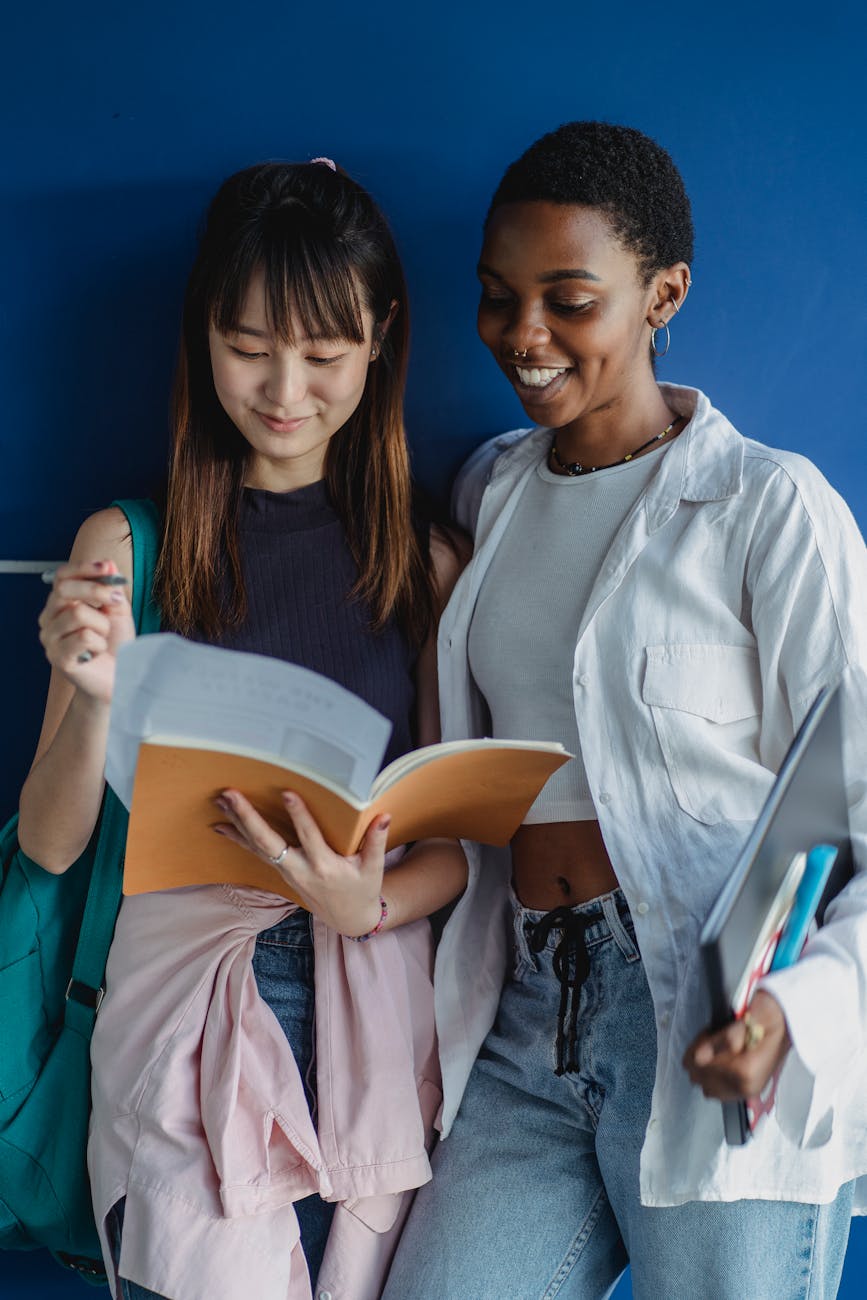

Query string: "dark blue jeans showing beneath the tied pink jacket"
[[109, 911, 334, 1300]]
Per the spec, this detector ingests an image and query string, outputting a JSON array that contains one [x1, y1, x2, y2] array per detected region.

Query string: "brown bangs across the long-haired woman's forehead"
[[209, 219, 364, 347]]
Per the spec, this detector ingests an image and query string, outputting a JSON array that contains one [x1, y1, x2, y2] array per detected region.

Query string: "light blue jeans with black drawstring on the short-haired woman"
[[383, 891, 851, 1300]]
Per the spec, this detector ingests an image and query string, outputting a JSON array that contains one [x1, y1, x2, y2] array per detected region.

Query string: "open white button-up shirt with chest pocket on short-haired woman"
[[437, 385, 867, 1209]]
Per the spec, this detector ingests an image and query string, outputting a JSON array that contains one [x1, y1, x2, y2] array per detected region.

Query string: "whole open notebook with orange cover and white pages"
[[107, 633, 571, 904]]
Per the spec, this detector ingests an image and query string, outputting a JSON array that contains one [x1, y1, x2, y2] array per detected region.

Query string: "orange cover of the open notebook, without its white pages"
[[123, 744, 569, 901]]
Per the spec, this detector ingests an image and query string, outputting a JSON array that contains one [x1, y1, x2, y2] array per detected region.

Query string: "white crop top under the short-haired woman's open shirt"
[[468, 447, 668, 824]]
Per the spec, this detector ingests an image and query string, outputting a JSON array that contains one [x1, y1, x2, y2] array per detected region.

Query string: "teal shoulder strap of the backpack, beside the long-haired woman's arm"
[[64, 501, 160, 1039]]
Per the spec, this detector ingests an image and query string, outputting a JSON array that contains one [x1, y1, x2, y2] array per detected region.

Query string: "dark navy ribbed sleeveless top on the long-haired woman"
[[204, 481, 416, 763]]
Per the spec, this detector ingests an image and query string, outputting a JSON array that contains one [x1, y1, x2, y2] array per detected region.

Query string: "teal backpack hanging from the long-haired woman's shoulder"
[[0, 501, 160, 1282]]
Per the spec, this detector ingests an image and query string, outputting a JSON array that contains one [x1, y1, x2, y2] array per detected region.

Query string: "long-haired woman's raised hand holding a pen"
[[39, 560, 135, 701]]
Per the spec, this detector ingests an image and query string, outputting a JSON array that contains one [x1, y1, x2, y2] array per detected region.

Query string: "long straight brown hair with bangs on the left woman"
[[155, 163, 434, 644]]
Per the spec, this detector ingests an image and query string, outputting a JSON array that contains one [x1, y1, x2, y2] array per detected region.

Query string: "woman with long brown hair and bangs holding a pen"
[[19, 160, 465, 1300]]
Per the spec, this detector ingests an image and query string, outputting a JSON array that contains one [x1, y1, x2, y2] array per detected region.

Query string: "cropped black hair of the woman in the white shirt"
[[485, 122, 694, 281]]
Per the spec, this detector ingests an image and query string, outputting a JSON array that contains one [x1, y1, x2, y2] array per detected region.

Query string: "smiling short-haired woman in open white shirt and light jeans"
[[386, 122, 867, 1300]]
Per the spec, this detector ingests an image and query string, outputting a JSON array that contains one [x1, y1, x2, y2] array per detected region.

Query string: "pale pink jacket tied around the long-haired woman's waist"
[[88, 863, 441, 1300]]
